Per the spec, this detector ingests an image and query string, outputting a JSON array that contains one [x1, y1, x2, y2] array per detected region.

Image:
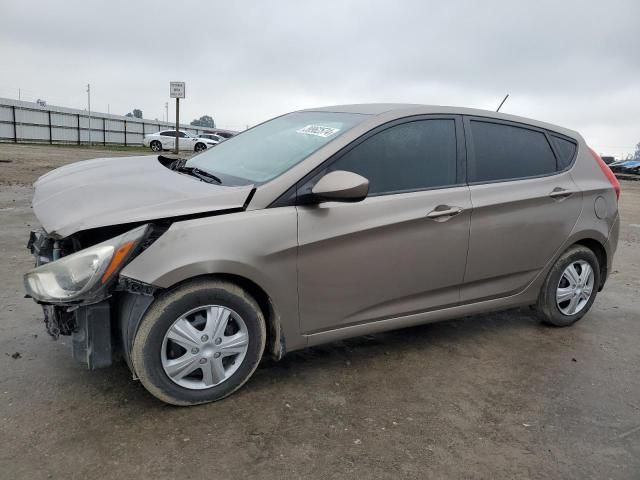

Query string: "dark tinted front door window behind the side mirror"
[[330, 119, 457, 195]]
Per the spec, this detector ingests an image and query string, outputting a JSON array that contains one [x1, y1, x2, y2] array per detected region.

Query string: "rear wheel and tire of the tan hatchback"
[[535, 245, 600, 327]]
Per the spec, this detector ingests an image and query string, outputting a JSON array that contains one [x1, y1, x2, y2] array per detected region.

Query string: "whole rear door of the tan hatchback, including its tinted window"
[[461, 117, 582, 302]]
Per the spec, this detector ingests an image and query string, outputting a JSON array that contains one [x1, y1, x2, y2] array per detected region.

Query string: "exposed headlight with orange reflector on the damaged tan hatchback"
[[24, 225, 148, 303]]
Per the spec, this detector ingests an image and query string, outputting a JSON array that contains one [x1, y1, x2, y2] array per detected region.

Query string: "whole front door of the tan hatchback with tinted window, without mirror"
[[298, 116, 471, 333]]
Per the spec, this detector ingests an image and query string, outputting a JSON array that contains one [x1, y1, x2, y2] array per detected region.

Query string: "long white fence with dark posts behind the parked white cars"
[[0, 98, 235, 145]]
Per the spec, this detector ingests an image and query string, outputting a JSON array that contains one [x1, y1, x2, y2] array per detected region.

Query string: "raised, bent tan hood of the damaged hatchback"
[[33, 155, 253, 238]]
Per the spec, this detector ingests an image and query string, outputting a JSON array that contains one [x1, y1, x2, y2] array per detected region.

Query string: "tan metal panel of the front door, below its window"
[[298, 186, 471, 333]]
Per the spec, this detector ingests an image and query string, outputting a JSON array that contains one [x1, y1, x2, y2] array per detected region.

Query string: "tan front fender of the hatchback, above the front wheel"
[[122, 207, 306, 350]]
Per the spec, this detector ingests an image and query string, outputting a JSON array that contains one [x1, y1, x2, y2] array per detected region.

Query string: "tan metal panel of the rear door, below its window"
[[461, 172, 582, 302]]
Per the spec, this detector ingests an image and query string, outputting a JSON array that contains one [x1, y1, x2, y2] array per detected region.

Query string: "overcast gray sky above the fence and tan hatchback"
[[0, 0, 640, 155]]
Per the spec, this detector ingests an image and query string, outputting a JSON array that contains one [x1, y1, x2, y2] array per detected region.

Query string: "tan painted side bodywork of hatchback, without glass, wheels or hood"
[[117, 105, 619, 351]]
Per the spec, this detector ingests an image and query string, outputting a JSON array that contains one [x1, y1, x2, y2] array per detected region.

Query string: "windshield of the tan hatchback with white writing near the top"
[[186, 112, 366, 184]]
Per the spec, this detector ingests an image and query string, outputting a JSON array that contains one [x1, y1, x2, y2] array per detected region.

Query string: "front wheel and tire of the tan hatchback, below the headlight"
[[131, 279, 266, 406]]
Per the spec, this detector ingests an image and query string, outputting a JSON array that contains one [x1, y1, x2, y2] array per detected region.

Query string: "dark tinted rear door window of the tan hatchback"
[[470, 120, 557, 182]]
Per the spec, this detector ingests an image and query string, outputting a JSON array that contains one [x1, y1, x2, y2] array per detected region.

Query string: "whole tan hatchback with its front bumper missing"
[[25, 104, 620, 405]]
